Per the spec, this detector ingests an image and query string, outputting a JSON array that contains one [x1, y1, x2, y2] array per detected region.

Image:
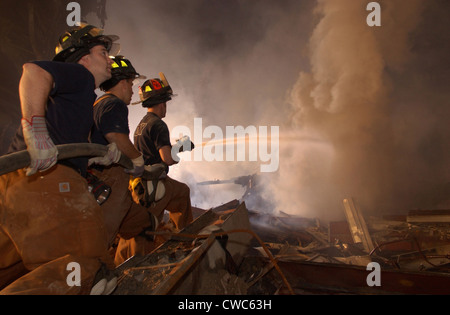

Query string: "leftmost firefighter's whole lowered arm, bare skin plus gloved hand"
[[19, 63, 58, 176]]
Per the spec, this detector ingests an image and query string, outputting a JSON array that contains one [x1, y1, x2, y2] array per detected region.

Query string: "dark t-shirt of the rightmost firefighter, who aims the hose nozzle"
[[134, 113, 172, 165]]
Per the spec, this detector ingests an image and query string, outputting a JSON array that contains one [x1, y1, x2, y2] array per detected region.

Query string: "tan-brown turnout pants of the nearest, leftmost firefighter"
[[0, 164, 114, 294]]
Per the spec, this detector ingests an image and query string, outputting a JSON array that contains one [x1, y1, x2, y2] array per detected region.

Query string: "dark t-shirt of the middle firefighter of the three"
[[90, 94, 130, 145]]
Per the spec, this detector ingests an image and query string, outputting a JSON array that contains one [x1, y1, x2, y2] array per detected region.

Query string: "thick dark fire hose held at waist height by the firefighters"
[[0, 143, 133, 175]]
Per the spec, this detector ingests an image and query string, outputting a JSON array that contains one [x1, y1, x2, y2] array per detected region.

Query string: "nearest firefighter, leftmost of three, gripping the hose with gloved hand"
[[0, 24, 120, 294]]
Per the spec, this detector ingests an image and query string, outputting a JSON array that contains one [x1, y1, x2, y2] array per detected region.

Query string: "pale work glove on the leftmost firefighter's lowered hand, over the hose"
[[22, 116, 58, 176]]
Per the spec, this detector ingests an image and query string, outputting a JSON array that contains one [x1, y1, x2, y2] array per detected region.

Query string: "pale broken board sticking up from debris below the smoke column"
[[342, 198, 375, 253]]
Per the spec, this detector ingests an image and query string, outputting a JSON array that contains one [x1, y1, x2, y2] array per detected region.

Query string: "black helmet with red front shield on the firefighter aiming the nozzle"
[[135, 72, 174, 107]]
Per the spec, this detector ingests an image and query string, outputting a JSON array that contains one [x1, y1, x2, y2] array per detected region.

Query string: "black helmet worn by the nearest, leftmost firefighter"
[[53, 23, 120, 62]]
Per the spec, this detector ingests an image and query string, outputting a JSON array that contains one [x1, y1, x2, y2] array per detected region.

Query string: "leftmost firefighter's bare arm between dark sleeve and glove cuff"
[[19, 63, 54, 121]]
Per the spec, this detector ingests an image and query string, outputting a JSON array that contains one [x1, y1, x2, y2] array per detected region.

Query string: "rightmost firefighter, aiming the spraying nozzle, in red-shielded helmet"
[[116, 73, 194, 263]]
